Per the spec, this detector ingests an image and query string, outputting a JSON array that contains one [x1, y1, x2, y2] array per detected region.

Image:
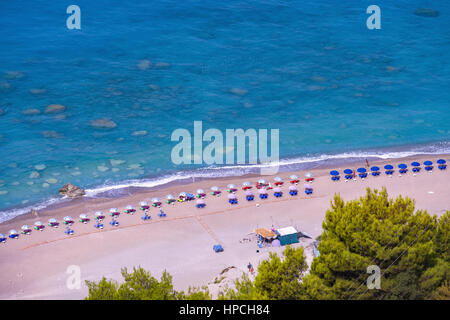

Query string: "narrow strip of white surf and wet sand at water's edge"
[[0, 153, 450, 230]]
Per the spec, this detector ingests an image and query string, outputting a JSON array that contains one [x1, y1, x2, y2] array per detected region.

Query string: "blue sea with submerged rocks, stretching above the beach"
[[0, 0, 450, 220]]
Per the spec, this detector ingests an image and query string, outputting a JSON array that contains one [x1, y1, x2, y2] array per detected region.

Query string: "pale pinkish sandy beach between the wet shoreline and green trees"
[[0, 155, 450, 299]]
